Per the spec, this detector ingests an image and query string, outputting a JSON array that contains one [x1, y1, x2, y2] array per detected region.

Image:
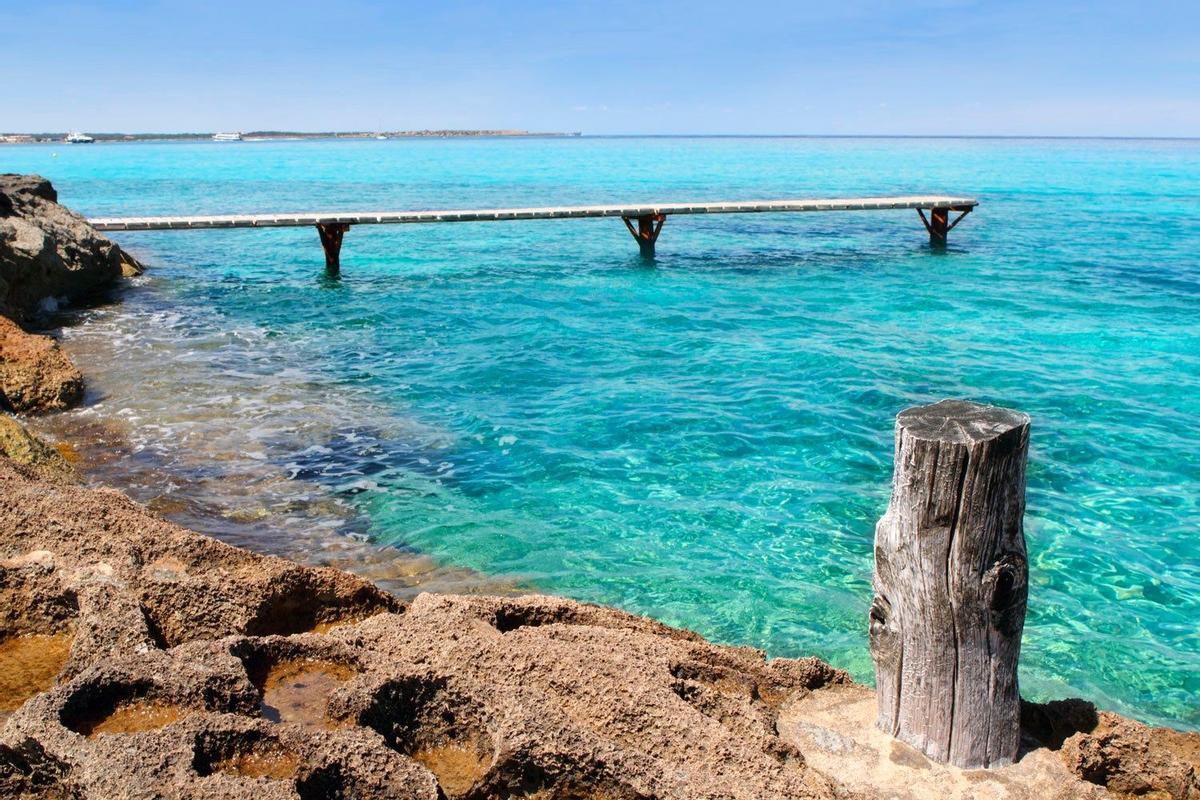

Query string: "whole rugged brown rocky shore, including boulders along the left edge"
[[0, 176, 1200, 800]]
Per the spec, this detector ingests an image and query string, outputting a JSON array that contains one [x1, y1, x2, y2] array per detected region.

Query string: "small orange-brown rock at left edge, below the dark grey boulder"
[[0, 315, 83, 413]]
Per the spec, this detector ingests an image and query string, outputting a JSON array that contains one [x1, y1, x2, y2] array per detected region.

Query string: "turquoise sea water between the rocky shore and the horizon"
[[0, 139, 1200, 728]]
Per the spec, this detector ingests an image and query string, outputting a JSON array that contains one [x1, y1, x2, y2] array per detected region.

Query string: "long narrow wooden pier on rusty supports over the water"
[[88, 194, 979, 275]]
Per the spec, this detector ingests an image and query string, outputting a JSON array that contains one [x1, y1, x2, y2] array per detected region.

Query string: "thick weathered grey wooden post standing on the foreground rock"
[[870, 401, 1030, 769]]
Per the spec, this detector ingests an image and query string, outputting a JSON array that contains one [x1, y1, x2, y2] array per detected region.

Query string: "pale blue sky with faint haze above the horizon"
[[0, 0, 1200, 137]]
